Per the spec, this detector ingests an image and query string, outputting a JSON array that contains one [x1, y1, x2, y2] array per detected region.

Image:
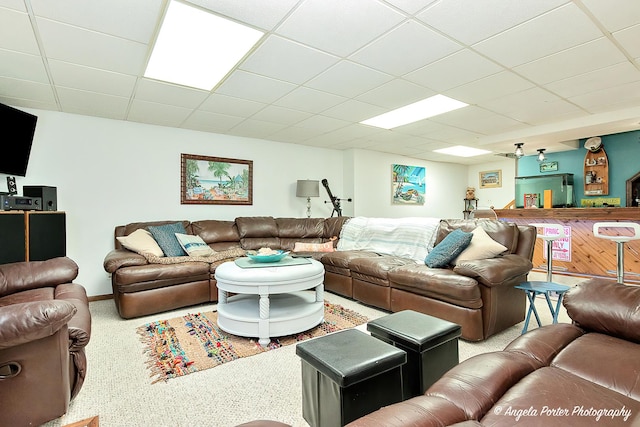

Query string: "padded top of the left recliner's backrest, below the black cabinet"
[[0, 257, 78, 297]]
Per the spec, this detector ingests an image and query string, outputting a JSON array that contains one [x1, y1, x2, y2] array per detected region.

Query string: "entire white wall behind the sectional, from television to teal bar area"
[[0, 110, 513, 296]]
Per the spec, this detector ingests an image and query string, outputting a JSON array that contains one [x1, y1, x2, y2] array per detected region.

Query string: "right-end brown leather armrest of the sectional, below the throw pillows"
[[453, 254, 533, 287]]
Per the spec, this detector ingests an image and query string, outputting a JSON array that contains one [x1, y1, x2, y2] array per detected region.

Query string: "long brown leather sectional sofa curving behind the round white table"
[[104, 217, 536, 341]]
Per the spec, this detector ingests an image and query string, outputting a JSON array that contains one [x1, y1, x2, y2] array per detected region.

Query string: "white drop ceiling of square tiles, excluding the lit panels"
[[0, 0, 640, 164]]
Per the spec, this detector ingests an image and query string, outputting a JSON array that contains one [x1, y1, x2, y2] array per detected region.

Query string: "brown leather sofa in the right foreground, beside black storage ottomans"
[[348, 279, 640, 427]]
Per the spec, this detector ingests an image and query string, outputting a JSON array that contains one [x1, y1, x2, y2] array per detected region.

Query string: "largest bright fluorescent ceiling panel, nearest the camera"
[[144, 1, 263, 90]]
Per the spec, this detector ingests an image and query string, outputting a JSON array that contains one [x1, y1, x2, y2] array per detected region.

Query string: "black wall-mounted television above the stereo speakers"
[[0, 104, 38, 176]]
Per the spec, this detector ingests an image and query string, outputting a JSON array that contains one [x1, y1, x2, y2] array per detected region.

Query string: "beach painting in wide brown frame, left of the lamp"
[[180, 154, 253, 205]]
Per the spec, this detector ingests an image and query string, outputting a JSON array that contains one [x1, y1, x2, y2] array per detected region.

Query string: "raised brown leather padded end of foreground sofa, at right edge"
[[563, 279, 640, 343]]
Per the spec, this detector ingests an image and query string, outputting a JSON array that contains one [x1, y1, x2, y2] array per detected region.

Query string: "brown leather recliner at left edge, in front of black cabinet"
[[0, 257, 91, 426]]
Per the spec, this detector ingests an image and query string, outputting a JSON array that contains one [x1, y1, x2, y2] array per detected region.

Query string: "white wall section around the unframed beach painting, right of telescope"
[[345, 150, 467, 218]]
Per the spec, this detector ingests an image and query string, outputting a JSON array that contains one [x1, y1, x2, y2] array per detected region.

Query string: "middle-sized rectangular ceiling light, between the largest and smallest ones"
[[360, 95, 469, 129]]
